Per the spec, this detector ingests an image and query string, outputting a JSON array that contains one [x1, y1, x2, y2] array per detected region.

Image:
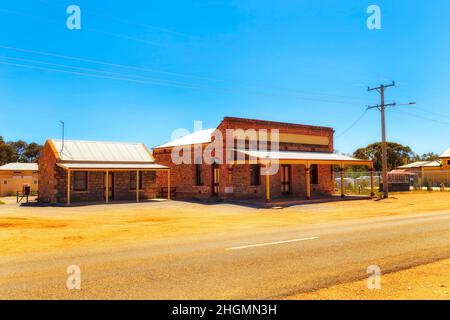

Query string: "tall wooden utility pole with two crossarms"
[[367, 81, 415, 199]]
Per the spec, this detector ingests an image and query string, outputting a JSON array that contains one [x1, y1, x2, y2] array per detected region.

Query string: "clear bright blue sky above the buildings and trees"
[[0, 0, 450, 153]]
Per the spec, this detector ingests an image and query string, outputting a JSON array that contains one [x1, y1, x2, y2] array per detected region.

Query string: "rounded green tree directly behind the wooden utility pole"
[[353, 142, 414, 171]]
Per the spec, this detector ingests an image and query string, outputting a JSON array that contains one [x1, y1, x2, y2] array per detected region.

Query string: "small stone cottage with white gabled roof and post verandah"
[[39, 139, 170, 205]]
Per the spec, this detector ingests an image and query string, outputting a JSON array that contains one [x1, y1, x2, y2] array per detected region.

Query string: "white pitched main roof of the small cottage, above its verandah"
[[51, 139, 154, 162]]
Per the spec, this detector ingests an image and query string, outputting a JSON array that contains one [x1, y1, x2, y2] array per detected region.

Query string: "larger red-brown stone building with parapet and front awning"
[[153, 117, 373, 201]]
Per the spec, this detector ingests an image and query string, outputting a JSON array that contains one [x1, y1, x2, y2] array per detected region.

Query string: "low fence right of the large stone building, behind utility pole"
[[333, 170, 450, 195]]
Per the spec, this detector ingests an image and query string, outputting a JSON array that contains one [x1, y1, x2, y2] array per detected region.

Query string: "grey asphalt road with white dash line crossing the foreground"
[[0, 212, 450, 299]]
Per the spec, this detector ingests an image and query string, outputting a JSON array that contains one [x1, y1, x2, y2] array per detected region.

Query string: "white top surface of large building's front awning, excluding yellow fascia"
[[236, 150, 370, 162]]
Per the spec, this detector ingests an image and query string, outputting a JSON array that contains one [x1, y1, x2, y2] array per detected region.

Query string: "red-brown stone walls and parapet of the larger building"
[[153, 118, 334, 199]]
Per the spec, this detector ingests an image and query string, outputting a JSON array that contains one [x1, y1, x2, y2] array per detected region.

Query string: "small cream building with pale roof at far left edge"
[[0, 162, 39, 197]]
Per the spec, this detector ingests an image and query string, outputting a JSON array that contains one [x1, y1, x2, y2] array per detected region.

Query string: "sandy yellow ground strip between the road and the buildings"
[[0, 193, 450, 256]]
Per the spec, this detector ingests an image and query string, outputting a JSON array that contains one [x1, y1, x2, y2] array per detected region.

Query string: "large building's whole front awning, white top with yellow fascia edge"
[[236, 150, 372, 166]]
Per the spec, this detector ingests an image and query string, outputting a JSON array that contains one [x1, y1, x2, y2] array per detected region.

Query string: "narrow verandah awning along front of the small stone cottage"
[[57, 162, 170, 171]]
